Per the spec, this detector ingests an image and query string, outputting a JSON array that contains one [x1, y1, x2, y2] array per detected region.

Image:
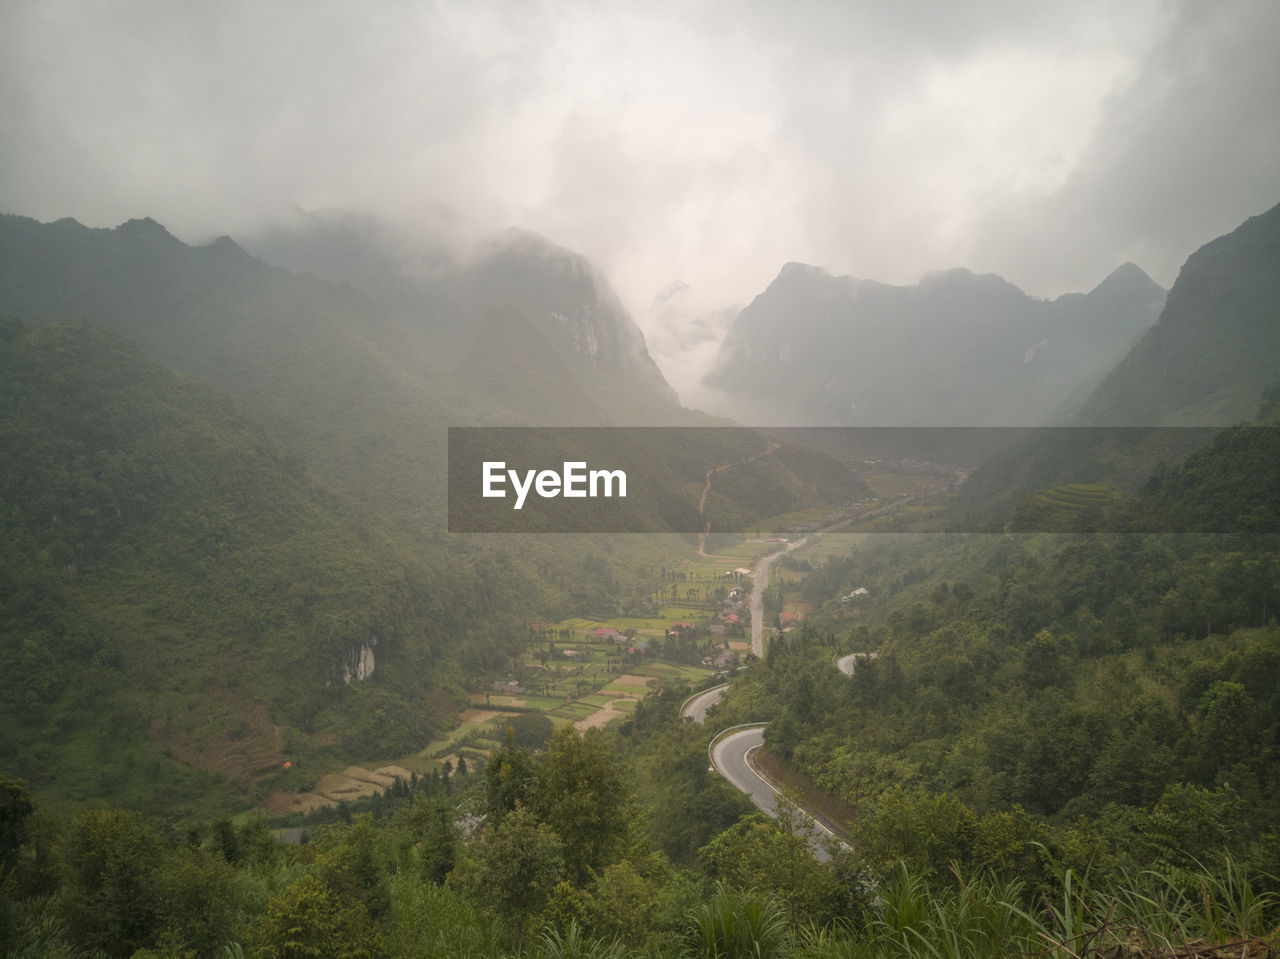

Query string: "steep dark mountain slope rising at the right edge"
[[956, 206, 1280, 525]]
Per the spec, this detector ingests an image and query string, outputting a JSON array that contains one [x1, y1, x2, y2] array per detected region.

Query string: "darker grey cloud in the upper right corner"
[[973, 0, 1280, 292]]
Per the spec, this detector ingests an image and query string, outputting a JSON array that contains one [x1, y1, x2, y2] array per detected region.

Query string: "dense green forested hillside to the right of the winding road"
[[733, 399, 1280, 871]]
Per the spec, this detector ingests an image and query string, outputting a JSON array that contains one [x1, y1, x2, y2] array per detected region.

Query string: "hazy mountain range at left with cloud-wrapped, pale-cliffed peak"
[[0, 215, 691, 526]]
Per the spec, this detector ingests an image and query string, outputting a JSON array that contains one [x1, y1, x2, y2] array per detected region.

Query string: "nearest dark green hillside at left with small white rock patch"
[[0, 320, 509, 816]]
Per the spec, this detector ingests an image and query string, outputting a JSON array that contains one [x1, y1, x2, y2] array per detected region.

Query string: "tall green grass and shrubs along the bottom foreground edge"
[[368, 860, 1280, 959]]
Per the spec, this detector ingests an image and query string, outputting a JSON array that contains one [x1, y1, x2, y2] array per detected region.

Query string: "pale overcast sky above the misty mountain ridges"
[[0, 0, 1280, 324]]
